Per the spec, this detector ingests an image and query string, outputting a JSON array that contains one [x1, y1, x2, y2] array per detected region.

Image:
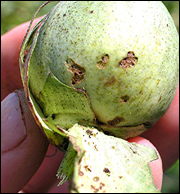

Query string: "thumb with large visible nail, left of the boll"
[[1, 91, 48, 193]]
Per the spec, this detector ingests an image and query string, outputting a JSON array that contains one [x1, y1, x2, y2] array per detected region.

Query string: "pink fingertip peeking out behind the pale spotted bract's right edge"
[[128, 136, 163, 191]]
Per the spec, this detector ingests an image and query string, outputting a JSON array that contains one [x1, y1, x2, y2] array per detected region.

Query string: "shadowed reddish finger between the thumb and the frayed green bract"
[[22, 145, 68, 193]]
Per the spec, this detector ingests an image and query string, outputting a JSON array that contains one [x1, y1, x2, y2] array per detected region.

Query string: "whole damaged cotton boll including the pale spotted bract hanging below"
[[20, 1, 179, 193]]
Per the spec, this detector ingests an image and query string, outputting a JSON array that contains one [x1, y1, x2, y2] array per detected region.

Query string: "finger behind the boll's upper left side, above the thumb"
[[1, 17, 42, 100]]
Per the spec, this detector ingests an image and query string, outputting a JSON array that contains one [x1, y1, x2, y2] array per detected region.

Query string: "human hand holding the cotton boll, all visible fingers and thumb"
[[1, 19, 179, 192]]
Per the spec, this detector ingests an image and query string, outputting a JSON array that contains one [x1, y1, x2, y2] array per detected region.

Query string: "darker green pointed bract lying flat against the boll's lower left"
[[37, 73, 94, 129]]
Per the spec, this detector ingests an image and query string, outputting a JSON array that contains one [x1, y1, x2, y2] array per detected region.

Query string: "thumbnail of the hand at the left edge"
[[1, 92, 27, 153]]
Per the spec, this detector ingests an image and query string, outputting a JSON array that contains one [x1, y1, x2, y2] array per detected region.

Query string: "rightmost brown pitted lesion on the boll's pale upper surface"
[[119, 51, 138, 70]]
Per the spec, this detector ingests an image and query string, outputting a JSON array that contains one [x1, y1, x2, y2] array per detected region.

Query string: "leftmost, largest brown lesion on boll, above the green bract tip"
[[65, 58, 86, 86]]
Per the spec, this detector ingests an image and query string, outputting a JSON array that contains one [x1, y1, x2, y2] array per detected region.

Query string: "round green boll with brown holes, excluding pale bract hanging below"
[[20, 1, 179, 145]]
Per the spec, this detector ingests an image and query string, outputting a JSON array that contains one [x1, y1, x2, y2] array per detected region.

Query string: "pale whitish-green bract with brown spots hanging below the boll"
[[59, 124, 159, 193]]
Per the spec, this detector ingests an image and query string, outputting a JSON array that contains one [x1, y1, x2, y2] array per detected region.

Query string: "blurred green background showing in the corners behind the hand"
[[1, 1, 179, 193]]
